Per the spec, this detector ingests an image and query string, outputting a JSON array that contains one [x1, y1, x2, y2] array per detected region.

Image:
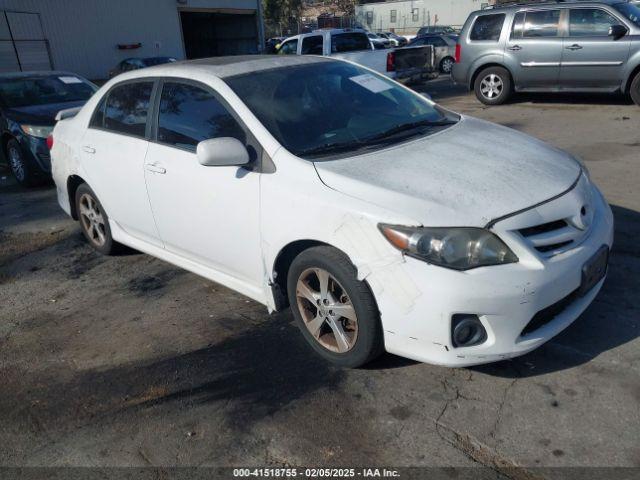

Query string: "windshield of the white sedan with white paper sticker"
[[225, 61, 458, 158]]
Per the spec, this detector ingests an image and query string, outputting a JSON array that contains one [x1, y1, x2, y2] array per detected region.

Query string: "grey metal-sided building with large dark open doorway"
[[0, 0, 264, 79]]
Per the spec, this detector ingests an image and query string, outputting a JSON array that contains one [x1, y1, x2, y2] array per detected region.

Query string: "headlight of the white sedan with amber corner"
[[379, 224, 518, 270]]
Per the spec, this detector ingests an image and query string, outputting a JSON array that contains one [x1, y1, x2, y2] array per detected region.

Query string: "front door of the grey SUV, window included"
[[560, 7, 630, 89]]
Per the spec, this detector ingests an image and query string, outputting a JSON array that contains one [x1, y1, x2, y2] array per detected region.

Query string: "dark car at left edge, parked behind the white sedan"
[[0, 72, 97, 186]]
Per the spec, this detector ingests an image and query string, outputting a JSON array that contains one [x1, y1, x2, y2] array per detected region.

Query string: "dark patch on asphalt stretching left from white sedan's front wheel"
[[17, 314, 346, 430]]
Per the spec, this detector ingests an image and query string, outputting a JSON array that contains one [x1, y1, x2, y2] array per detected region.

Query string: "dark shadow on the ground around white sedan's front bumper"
[[470, 205, 640, 378]]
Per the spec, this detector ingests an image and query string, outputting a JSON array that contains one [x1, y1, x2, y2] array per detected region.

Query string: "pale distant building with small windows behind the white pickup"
[[356, 0, 489, 34]]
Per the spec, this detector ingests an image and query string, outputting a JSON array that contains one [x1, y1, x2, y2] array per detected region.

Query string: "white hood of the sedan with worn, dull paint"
[[315, 117, 580, 227]]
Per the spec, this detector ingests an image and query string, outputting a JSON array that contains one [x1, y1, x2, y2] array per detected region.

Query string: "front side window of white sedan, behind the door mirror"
[[158, 82, 246, 151]]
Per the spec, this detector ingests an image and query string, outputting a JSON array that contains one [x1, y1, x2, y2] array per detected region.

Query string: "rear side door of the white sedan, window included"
[[81, 80, 162, 246]]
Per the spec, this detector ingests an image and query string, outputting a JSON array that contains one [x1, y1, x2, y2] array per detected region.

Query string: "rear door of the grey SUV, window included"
[[505, 9, 562, 89]]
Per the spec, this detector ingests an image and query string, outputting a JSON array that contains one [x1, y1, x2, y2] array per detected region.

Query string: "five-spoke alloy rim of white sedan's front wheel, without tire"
[[296, 268, 358, 353]]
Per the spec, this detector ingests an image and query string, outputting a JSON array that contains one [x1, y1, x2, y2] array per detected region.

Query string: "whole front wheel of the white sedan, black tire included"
[[287, 246, 384, 368]]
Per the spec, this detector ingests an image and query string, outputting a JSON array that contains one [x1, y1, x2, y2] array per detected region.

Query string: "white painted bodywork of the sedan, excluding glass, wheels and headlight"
[[51, 56, 613, 366]]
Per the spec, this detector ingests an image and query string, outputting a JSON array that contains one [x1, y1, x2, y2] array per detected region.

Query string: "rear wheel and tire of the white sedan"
[[75, 183, 122, 255]]
